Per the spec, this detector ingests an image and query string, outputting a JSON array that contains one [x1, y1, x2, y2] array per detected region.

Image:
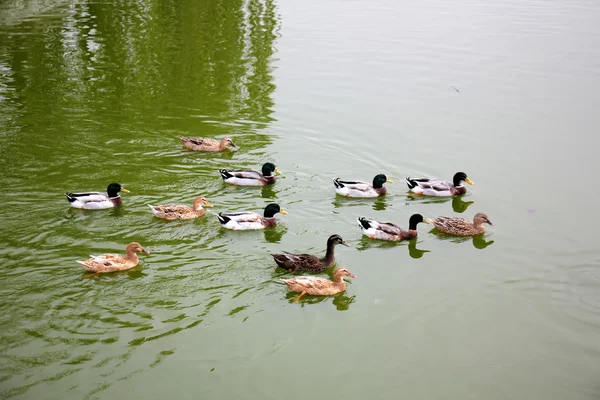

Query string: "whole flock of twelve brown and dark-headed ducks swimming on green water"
[[65, 136, 494, 301]]
